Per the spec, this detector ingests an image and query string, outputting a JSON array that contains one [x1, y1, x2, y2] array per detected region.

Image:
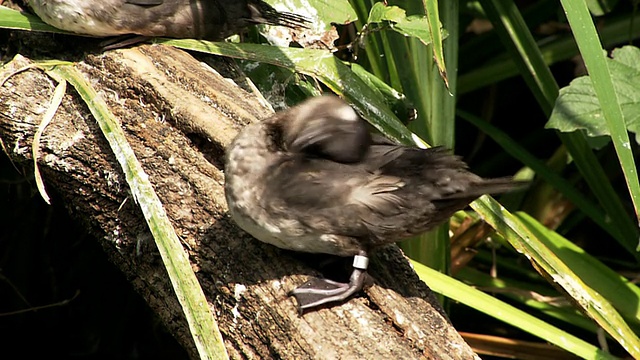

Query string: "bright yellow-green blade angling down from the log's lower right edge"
[[412, 261, 616, 359]]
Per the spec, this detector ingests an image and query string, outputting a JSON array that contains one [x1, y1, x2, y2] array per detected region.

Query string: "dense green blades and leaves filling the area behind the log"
[[0, 0, 640, 358]]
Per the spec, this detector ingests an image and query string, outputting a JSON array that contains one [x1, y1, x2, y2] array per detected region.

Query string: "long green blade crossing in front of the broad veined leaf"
[[561, 0, 640, 229]]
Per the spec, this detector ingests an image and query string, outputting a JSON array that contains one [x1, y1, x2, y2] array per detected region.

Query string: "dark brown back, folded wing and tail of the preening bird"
[[265, 144, 514, 246]]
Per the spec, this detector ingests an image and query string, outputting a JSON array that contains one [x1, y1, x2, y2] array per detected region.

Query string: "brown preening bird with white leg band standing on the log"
[[225, 95, 518, 312]]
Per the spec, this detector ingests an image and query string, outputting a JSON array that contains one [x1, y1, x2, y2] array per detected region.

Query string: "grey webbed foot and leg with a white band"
[[289, 252, 369, 313]]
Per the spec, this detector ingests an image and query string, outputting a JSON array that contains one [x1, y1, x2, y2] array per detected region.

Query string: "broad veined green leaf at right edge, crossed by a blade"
[[546, 46, 640, 142]]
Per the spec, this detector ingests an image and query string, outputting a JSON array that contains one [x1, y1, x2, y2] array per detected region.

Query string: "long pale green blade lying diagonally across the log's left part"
[[49, 66, 229, 359]]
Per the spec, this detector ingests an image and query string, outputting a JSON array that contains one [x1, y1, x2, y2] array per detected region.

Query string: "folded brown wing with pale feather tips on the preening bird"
[[262, 146, 424, 239]]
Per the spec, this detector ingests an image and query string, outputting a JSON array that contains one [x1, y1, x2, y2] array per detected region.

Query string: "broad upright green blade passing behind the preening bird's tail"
[[388, 0, 458, 272]]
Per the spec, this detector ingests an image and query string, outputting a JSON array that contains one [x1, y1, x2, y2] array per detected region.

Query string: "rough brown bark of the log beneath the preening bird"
[[0, 33, 477, 359]]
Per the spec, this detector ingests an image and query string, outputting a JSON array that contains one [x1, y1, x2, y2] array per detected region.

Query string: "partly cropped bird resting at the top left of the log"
[[27, 0, 307, 40]]
